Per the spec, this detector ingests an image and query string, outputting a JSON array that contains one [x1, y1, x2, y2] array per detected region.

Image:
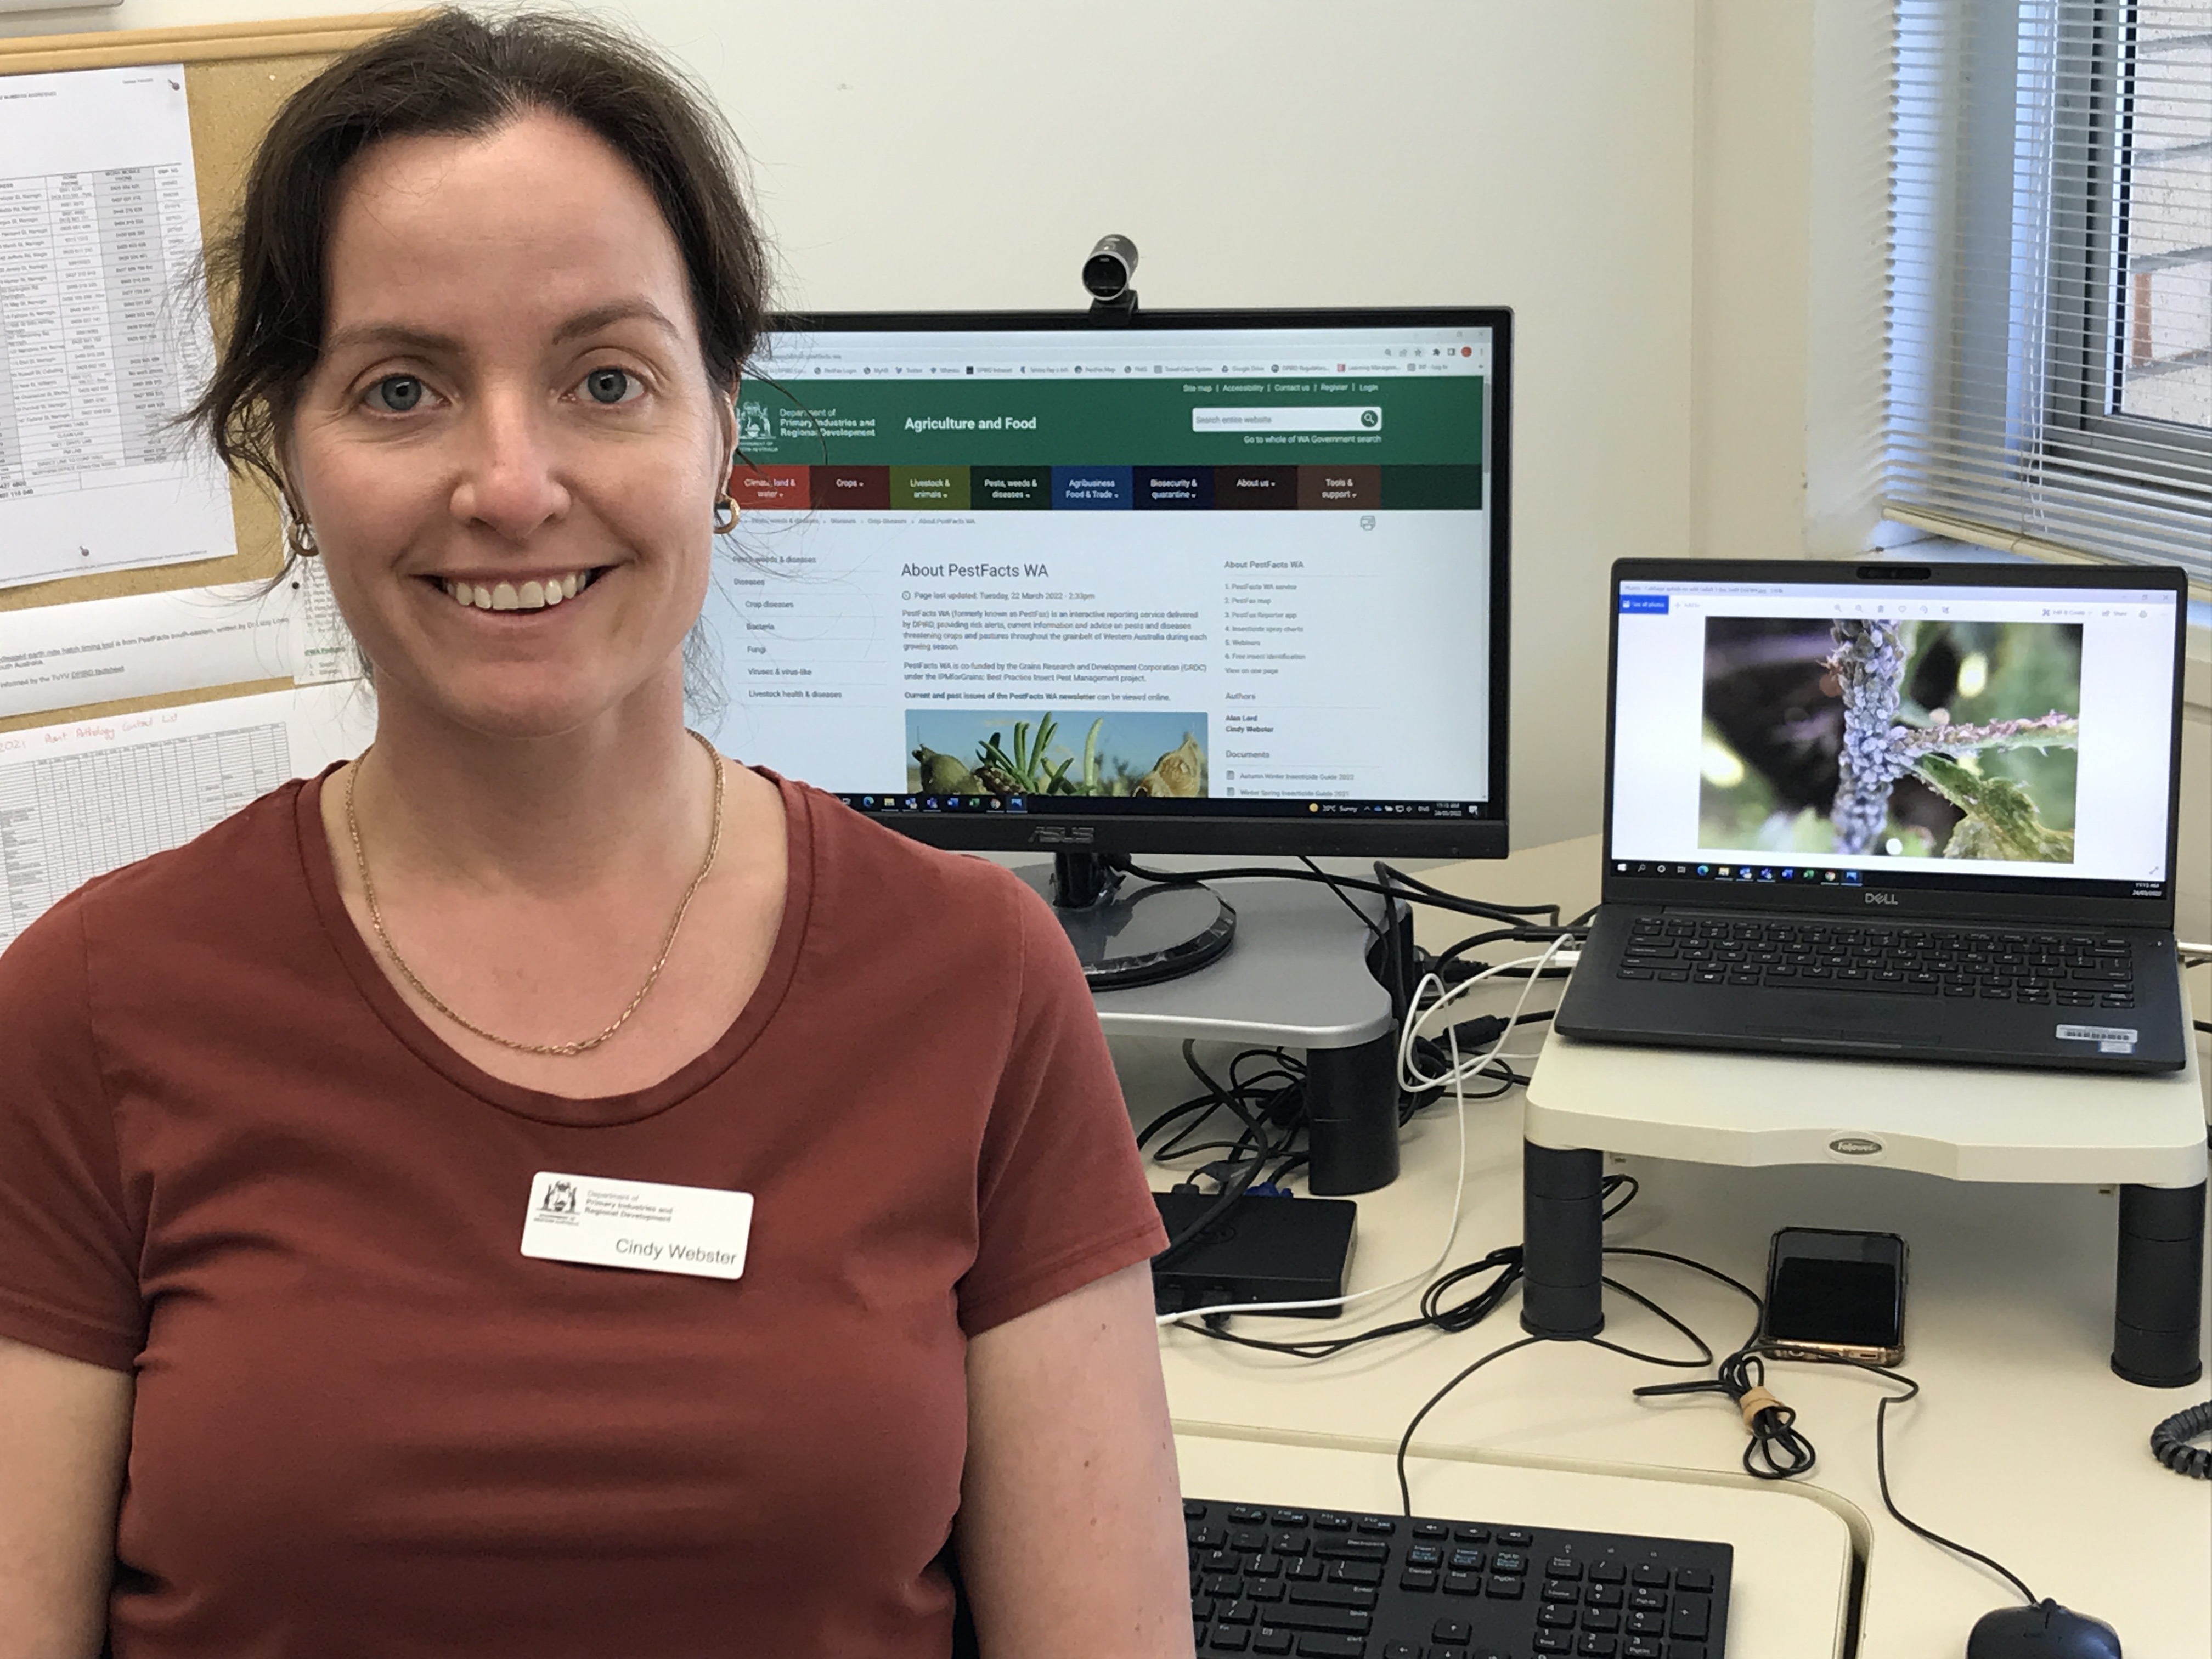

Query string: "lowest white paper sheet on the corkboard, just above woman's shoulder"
[[0, 681, 376, 949]]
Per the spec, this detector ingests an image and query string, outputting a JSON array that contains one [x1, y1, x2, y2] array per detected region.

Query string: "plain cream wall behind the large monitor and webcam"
[[0, 0, 1695, 845]]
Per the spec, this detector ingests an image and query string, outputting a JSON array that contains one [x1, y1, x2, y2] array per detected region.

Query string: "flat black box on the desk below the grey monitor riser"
[[1153, 1192, 1361, 1318]]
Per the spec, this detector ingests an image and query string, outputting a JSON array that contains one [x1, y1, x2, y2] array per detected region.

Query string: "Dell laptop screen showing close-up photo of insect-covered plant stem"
[[1606, 562, 2181, 902]]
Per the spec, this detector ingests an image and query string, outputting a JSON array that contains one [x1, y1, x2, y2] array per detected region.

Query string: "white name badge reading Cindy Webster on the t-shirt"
[[522, 1170, 752, 1278]]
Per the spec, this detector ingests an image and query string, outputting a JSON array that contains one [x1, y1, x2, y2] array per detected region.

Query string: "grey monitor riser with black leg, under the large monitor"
[[1015, 862, 1398, 1197]]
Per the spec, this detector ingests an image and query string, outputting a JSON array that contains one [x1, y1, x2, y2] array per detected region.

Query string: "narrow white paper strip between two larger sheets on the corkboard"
[[0, 560, 360, 719]]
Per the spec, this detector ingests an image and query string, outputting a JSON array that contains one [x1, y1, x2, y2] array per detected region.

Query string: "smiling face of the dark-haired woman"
[[285, 113, 735, 737]]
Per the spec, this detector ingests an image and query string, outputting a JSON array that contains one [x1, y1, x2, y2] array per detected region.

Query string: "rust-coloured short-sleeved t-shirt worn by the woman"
[[0, 783, 1164, 1659]]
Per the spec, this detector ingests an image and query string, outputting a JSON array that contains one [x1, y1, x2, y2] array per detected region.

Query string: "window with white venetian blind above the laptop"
[[1882, 0, 2212, 584]]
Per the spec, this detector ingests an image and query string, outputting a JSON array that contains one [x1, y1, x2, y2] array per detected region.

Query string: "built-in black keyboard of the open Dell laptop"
[[1615, 916, 2135, 1009]]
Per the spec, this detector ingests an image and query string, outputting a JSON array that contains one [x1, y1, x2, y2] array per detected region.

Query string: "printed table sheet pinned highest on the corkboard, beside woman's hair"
[[0, 64, 236, 586]]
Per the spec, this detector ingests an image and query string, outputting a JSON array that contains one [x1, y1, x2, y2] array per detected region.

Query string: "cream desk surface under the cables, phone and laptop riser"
[[1115, 840, 2212, 1659]]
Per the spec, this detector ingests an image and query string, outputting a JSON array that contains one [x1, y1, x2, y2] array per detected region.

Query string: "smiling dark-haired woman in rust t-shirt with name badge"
[[0, 13, 1190, 1659]]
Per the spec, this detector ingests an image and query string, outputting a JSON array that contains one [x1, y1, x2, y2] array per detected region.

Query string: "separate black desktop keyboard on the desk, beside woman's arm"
[[1183, 1500, 1734, 1659]]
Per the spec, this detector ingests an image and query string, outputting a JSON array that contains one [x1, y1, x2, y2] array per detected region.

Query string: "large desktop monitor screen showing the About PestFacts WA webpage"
[[708, 309, 1511, 856]]
